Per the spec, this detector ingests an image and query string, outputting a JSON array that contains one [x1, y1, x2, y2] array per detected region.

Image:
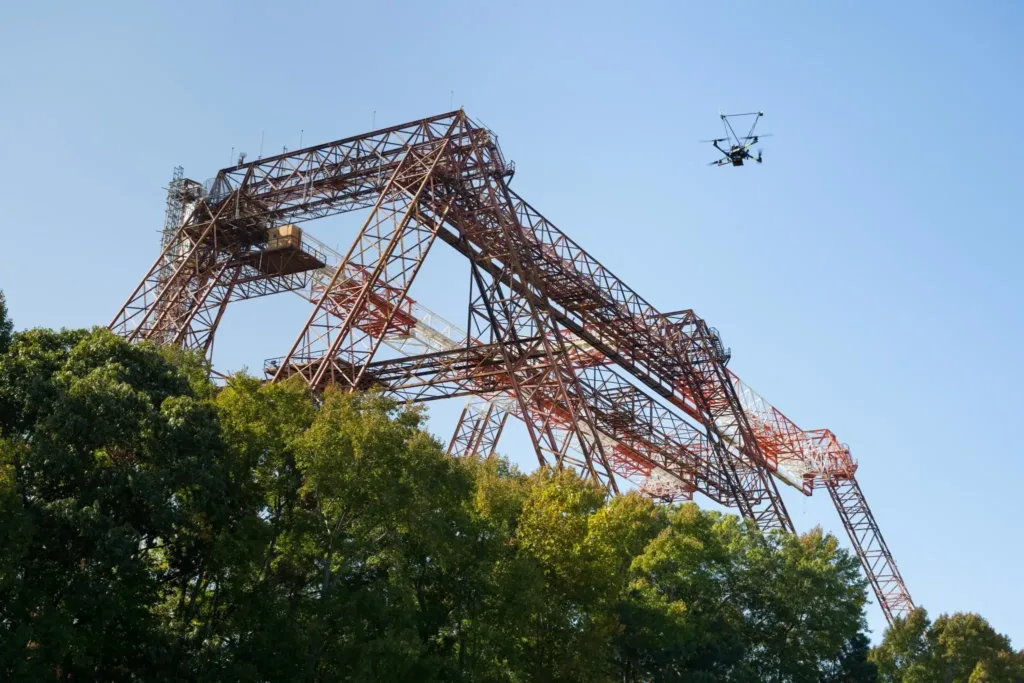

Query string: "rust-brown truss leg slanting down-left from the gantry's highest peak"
[[273, 124, 459, 389]]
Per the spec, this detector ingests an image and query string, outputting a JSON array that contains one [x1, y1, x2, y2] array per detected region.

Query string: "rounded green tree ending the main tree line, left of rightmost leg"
[[620, 504, 865, 682]]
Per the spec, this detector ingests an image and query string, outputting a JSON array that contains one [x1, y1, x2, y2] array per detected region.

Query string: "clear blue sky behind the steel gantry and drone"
[[0, 1, 1024, 647]]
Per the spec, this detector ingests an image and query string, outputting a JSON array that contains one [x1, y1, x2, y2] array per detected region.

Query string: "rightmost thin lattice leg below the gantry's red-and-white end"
[[825, 477, 913, 624]]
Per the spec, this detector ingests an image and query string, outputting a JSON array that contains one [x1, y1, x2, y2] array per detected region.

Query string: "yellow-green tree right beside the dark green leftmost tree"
[[201, 377, 492, 681]]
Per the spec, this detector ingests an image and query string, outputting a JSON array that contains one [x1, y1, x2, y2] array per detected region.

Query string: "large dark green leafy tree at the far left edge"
[[0, 331, 233, 681]]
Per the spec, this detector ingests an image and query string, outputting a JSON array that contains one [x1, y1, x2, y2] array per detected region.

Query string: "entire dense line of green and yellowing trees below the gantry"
[[0, 297, 1021, 683]]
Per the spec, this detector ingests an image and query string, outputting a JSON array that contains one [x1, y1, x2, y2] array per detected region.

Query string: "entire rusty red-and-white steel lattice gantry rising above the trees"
[[111, 111, 912, 618]]
